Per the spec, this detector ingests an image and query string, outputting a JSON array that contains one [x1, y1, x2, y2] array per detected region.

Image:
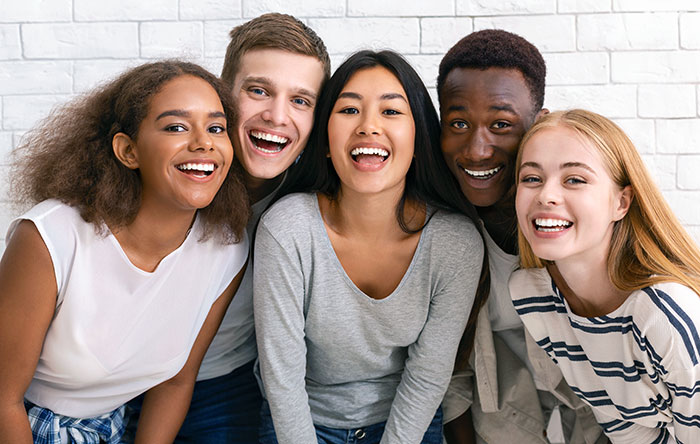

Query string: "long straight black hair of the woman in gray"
[[282, 50, 489, 363]]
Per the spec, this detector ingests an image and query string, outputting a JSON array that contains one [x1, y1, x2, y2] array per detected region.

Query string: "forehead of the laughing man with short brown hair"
[[234, 48, 323, 92]]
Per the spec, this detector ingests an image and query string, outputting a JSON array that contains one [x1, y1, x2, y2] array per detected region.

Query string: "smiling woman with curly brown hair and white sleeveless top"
[[0, 61, 248, 444]]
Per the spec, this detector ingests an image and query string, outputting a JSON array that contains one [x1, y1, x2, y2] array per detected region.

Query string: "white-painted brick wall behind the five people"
[[0, 0, 700, 253]]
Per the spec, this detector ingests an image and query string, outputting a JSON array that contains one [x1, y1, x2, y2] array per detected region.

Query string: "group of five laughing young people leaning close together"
[[0, 9, 700, 444]]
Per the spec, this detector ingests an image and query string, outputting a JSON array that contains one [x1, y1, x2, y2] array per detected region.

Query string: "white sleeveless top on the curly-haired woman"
[[6, 200, 248, 418]]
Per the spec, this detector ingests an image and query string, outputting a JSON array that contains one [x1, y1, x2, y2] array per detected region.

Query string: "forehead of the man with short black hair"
[[440, 68, 534, 114]]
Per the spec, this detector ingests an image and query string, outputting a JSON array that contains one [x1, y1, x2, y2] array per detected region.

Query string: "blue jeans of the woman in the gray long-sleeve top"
[[260, 401, 442, 444]]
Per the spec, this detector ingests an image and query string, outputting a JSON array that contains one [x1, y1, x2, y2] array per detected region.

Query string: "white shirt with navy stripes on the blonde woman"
[[509, 269, 700, 444]]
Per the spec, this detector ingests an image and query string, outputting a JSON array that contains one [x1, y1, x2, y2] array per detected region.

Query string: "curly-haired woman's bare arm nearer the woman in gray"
[[134, 267, 245, 444]]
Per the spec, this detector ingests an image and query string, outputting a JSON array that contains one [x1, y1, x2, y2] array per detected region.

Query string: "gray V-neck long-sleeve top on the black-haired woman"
[[253, 194, 483, 444]]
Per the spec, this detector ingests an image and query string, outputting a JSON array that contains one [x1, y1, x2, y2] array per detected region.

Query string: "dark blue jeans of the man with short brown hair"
[[126, 361, 262, 444]]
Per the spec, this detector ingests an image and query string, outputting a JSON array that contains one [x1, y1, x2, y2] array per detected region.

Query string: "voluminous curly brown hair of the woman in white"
[[12, 60, 249, 243]]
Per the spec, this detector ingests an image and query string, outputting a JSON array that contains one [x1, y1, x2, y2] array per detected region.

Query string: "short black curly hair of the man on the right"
[[437, 29, 547, 112]]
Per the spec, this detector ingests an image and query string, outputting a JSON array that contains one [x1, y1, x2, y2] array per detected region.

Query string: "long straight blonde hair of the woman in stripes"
[[515, 109, 700, 295]]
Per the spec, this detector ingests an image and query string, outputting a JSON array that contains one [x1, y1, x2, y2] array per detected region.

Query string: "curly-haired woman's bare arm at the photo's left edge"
[[0, 220, 58, 444]]
